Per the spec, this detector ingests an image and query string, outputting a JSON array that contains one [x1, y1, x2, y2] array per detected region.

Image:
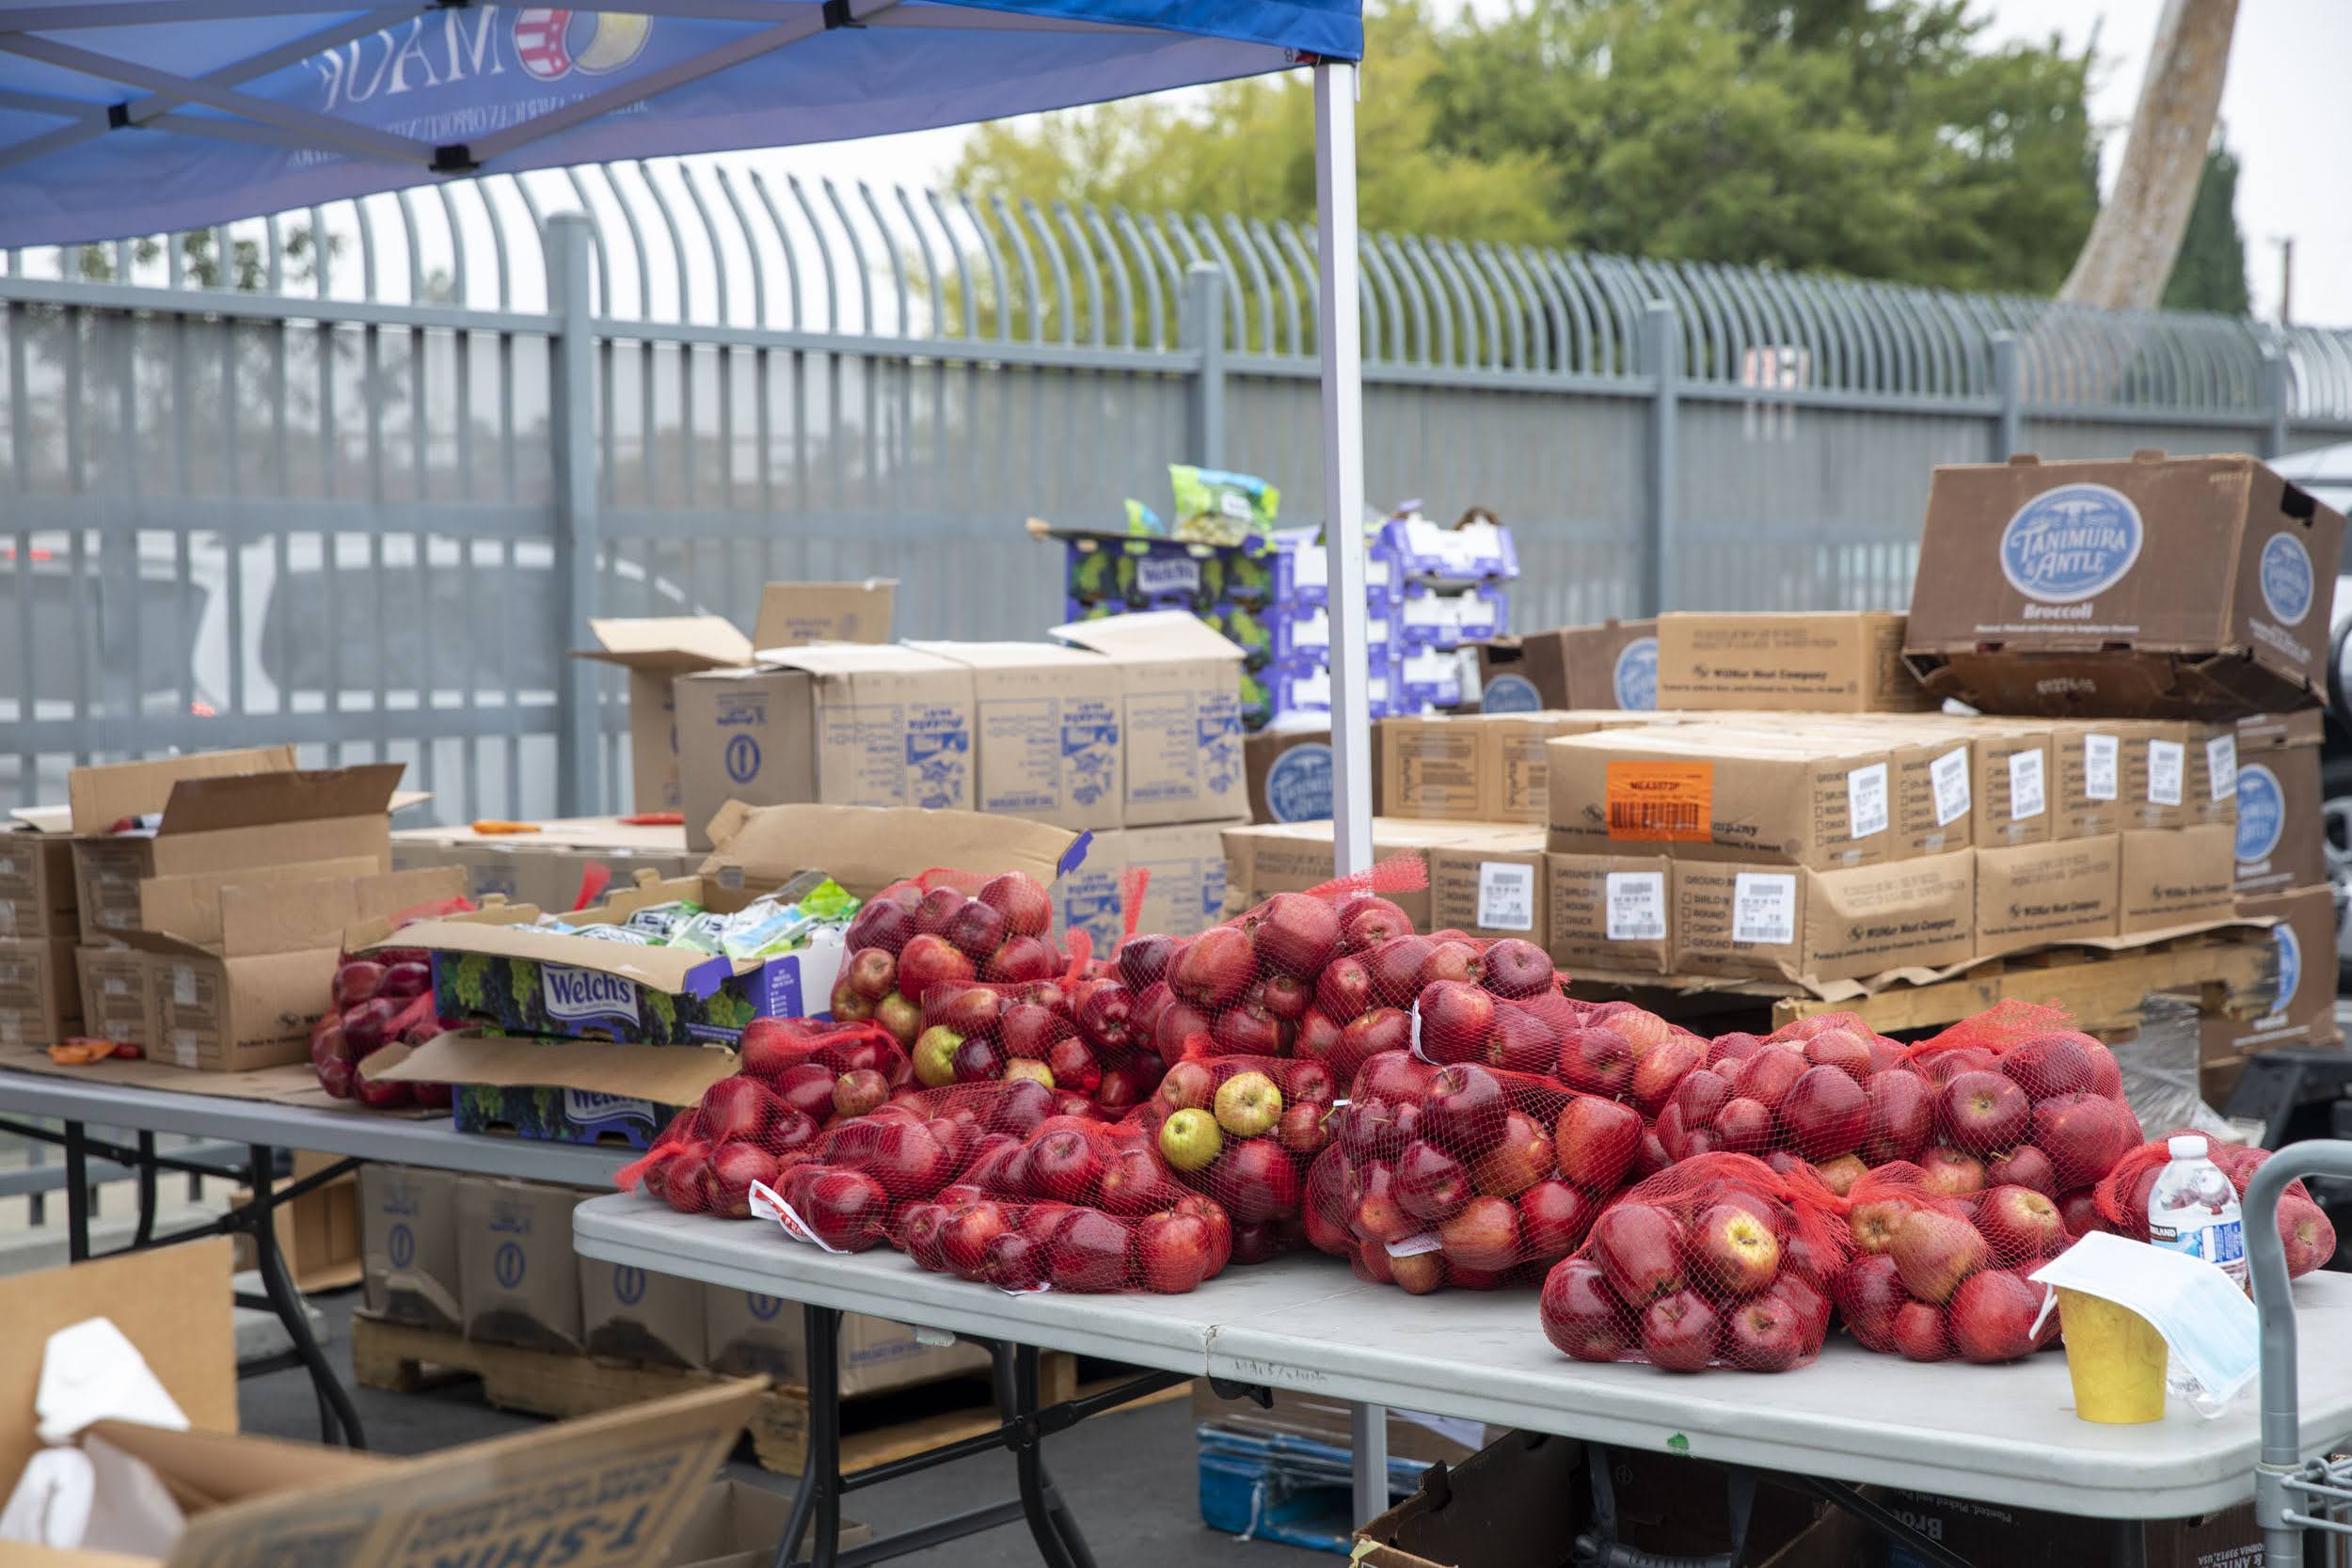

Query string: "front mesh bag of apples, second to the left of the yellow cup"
[[1538, 1154, 1847, 1373]]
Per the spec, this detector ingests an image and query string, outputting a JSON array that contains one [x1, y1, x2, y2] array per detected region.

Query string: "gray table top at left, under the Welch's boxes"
[[0, 1069, 635, 1187]]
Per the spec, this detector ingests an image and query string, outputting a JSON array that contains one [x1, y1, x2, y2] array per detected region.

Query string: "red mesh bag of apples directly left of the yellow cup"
[[1830, 1162, 2073, 1364]]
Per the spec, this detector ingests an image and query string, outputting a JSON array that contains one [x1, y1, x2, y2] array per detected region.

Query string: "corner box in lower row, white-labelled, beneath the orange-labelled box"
[[1668, 848, 1976, 983]]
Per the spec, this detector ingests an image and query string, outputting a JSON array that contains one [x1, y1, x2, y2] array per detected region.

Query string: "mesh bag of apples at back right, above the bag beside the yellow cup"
[[1908, 1002, 2143, 1234]]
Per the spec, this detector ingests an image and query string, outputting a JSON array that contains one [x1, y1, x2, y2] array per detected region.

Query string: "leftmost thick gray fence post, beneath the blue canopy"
[[546, 212, 605, 816]]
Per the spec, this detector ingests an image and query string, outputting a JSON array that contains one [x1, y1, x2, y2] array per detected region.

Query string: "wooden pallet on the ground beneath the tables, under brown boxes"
[[351, 1317, 1188, 1477]]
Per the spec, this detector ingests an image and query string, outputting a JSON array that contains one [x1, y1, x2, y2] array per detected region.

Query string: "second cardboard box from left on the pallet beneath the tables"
[[456, 1176, 591, 1350]]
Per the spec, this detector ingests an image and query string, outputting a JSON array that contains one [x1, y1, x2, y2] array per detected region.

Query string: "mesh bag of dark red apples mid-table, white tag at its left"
[[1306, 1051, 1642, 1295]]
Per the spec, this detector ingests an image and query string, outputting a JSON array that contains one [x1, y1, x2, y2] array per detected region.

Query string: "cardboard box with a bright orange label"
[[1546, 726, 1894, 870]]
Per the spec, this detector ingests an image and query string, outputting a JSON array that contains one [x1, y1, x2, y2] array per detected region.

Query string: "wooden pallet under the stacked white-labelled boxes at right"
[[1571, 928, 2277, 1035]]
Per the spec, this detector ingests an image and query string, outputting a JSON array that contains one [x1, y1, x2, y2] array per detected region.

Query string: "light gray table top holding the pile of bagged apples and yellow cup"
[[572, 1195, 2352, 1519]]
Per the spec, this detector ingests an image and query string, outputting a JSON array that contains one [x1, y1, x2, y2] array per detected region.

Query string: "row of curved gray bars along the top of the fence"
[[5, 157, 2352, 423]]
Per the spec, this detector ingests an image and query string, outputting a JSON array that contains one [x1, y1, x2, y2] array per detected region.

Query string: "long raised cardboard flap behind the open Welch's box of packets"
[[701, 801, 1077, 898]]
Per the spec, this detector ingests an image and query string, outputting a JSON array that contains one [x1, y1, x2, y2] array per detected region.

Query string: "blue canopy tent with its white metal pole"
[[0, 0, 1388, 1519]]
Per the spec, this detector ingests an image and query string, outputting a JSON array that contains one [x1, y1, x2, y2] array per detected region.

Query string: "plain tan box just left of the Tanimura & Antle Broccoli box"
[[1659, 611, 1938, 712]]
